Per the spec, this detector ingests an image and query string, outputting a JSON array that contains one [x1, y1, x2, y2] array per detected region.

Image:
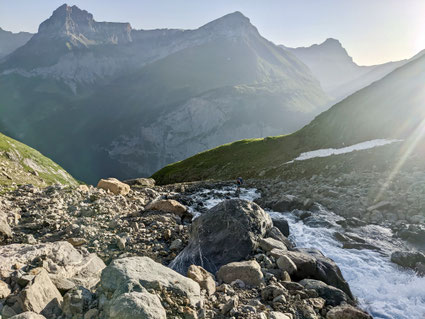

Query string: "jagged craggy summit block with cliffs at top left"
[[38, 4, 131, 46]]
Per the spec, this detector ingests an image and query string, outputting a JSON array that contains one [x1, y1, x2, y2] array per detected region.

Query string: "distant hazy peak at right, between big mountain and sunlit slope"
[[284, 38, 423, 101]]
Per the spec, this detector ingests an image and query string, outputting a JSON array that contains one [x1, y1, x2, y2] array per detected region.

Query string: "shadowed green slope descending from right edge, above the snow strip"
[[153, 52, 425, 183]]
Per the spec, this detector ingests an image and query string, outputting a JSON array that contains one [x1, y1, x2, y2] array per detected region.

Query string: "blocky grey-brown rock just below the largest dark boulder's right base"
[[217, 260, 264, 287]]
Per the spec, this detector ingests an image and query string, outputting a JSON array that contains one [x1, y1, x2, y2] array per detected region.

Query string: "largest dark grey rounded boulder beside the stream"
[[170, 199, 273, 274]]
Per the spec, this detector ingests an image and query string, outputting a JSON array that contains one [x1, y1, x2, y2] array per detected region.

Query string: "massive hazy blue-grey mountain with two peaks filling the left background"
[[0, 5, 328, 183]]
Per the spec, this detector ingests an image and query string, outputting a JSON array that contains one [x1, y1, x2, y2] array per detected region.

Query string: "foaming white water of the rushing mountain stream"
[[191, 187, 425, 319]]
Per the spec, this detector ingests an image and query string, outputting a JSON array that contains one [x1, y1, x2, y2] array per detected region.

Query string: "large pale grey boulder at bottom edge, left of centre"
[[98, 257, 201, 319]]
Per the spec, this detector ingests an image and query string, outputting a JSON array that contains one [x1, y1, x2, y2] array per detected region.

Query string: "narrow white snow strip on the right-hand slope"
[[286, 139, 402, 164]]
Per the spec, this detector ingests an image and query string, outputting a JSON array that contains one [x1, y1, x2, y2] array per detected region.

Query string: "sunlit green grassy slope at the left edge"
[[0, 133, 77, 187]]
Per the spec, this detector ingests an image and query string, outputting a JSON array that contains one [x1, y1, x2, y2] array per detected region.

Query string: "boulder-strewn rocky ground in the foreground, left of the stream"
[[0, 180, 371, 319]]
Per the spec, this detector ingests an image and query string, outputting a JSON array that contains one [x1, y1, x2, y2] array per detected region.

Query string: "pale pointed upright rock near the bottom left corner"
[[18, 269, 63, 318]]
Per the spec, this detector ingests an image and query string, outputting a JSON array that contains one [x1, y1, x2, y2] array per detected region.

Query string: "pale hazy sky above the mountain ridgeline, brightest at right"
[[0, 0, 425, 65]]
